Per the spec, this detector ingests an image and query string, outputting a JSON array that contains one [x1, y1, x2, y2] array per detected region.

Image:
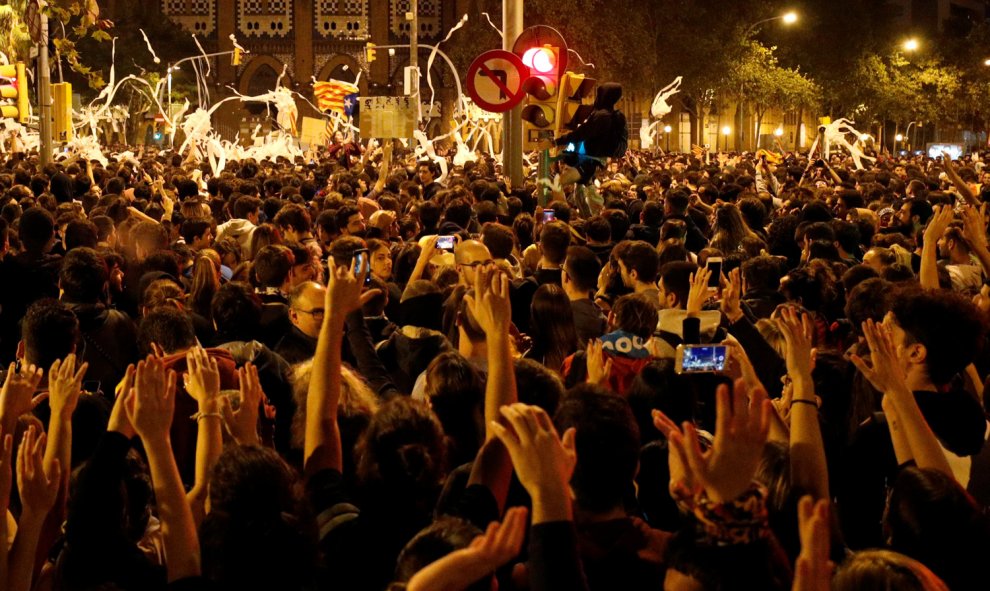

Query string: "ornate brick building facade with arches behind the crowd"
[[154, 0, 470, 136]]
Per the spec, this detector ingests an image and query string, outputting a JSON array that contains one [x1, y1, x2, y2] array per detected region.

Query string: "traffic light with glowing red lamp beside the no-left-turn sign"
[[522, 45, 560, 150]]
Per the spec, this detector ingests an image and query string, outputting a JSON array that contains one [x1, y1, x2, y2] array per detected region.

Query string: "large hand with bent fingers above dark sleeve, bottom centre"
[[491, 403, 577, 524]]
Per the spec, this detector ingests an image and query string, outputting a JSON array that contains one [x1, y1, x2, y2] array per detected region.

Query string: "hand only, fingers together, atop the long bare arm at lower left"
[[125, 356, 175, 443]]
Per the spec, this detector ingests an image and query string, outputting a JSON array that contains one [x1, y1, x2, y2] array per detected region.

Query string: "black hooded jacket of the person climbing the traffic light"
[[556, 82, 629, 158]]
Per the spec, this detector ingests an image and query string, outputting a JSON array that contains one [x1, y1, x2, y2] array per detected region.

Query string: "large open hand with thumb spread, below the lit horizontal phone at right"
[[668, 380, 772, 503]]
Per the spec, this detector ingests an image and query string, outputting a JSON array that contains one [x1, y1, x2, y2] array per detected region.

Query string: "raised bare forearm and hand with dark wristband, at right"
[[776, 308, 829, 499]]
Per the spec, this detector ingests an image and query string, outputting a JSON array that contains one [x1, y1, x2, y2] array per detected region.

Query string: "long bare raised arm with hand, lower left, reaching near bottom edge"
[[125, 356, 200, 583]]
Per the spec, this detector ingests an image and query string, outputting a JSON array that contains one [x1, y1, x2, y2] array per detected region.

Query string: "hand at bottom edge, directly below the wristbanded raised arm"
[[791, 495, 832, 591]]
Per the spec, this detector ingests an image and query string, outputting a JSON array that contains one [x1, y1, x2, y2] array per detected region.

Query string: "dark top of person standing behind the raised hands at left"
[[66, 303, 138, 398]]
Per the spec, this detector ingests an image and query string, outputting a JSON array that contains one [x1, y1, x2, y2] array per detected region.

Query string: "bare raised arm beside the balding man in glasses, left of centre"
[[303, 257, 366, 476]]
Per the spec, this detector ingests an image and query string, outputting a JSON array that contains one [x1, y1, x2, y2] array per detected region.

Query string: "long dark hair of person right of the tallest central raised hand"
[[530, 283, 579, 371]]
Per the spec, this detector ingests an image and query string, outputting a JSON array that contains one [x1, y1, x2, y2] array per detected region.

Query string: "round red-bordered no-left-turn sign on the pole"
[[467, 49, 529, 113]]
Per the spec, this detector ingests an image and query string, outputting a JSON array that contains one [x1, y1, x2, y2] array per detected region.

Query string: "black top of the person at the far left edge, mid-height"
[[0, 252, 62, 360]]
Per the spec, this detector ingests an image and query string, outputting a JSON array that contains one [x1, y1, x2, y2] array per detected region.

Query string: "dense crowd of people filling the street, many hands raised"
[[0, 120, 990, 591]]
